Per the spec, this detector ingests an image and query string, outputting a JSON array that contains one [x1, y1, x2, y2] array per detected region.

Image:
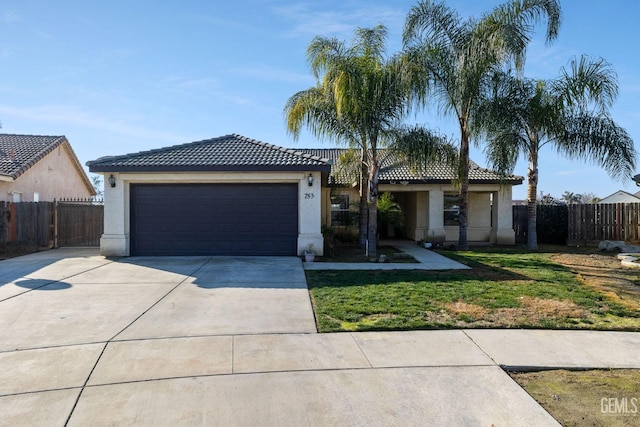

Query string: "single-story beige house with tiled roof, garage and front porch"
[[87, 134, 522, 256]]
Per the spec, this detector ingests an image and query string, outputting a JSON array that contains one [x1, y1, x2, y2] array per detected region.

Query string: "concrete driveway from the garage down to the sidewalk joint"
[[0, 249, 316, 351]]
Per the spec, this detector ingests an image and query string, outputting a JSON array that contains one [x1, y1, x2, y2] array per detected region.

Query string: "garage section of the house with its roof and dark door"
[[87, 134, 331, 256]]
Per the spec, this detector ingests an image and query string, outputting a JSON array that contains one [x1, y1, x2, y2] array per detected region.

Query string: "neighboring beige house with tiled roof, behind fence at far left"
[[0, 134, 96, 202]]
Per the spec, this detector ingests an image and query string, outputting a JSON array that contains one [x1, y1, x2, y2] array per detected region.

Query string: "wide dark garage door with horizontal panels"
[[131, 184, 298, 255]]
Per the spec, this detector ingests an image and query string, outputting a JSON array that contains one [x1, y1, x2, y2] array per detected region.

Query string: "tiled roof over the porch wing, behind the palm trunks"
[[301, 148, 523, 185]]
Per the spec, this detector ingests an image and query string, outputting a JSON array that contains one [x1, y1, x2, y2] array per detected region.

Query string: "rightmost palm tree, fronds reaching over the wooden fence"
[[480, 56, 636, 250]]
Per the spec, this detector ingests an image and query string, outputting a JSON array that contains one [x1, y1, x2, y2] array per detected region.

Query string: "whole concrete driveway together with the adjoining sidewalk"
[[5, 249, 640, 426]]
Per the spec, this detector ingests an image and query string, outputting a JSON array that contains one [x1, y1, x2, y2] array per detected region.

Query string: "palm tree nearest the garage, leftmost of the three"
[[285, 25, 456, 257]]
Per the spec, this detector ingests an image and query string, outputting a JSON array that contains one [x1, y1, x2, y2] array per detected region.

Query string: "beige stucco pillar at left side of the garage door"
[[100, 173, 130, 256]]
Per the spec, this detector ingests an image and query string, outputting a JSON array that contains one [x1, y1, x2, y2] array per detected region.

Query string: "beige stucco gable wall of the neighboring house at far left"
[[0, 142, 95, 202]]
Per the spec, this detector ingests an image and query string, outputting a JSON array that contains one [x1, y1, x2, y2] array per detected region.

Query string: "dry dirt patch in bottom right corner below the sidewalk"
[[510, 369, 640, 426]]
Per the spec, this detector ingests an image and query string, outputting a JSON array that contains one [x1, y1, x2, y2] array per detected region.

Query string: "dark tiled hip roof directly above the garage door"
[[87, 134, 331, 172]]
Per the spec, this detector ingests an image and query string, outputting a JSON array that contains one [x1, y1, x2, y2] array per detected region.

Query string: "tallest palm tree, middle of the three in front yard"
[[403, 0, 560, 250]]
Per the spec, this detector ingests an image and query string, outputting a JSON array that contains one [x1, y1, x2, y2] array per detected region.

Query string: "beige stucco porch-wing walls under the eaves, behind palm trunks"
[[322, 184, 515, 245]]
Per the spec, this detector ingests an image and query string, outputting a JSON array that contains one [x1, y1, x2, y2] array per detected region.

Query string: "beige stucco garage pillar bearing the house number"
[[298, 172, 324, 256]]
